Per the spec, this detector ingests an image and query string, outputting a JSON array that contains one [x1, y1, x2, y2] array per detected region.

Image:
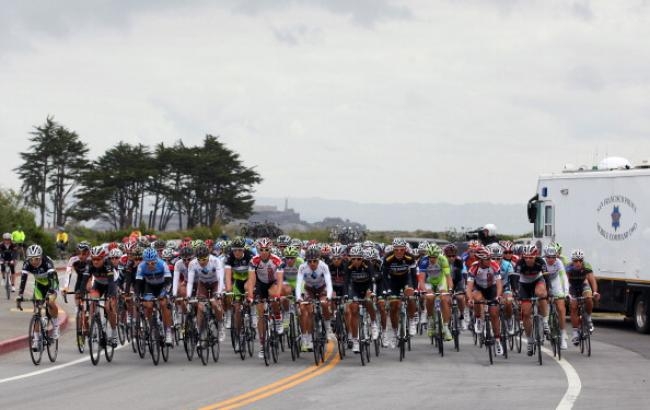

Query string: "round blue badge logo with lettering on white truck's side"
[[596, 195, 638, 241]]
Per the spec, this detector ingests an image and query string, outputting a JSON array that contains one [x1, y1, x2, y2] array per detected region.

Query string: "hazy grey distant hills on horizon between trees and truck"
[[255, 197, 532, 235]]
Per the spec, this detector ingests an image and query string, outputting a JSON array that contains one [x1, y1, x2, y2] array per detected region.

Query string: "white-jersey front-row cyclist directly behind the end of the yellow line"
[[296, 247, 333, 351]]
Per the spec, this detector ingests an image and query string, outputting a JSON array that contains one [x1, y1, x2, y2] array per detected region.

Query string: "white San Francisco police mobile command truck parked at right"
[[528, 157, 650, 333]]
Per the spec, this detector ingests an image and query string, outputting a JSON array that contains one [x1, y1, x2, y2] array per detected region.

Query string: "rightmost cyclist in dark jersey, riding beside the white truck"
[[566, 249, 600, 346]]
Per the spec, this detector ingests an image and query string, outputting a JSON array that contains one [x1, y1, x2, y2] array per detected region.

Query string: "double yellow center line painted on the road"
[[199, 343, 339, 410]]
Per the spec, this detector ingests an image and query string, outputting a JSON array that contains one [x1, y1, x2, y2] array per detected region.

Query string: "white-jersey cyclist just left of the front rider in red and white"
[[187, 245, 226, 342]]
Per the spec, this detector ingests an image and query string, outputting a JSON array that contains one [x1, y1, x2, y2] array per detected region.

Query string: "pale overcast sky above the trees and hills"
[[0, 0, 650, 203]]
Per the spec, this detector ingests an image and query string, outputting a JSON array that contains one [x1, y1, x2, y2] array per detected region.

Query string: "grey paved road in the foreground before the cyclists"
[[0, 310, 650, 410]]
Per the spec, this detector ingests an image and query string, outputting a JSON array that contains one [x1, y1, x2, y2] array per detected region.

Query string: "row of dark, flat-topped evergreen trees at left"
[[15, 116, 262, 231]]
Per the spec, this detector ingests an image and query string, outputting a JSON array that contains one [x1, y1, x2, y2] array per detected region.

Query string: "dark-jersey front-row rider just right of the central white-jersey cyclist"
[[344, 246, 379, 353]]
